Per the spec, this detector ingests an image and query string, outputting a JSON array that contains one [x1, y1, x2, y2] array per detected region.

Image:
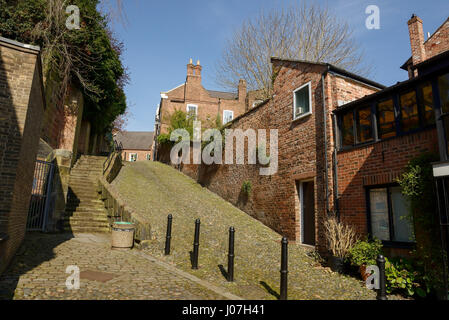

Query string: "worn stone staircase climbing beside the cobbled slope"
[[64, 156, 110, 233]]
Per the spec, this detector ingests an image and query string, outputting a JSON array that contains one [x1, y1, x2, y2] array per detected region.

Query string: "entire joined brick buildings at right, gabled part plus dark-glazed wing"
[[164, 16, 449, 252]]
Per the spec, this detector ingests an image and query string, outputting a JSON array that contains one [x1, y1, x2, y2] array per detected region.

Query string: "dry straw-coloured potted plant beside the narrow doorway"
[[324, 217, 357, 273]]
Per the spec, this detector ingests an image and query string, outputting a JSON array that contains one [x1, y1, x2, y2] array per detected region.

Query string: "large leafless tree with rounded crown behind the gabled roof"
[[216, 2, 368, 98]]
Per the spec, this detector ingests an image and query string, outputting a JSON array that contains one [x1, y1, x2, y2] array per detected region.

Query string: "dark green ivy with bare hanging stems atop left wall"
[[0, 0, 128, 133]]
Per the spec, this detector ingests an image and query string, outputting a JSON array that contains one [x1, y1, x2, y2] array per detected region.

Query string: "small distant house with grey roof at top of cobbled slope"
[[114, 131, 154, 162]]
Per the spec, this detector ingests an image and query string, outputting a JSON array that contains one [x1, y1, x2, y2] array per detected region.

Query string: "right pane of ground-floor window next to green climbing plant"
[[390, 187, 415, 242]]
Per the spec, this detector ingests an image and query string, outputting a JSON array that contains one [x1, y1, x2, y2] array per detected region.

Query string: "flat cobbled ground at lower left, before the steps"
[[0, 234, 225, 300]]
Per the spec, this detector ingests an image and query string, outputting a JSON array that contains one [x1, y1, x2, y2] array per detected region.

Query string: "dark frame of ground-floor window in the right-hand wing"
[[364, 183, 416, 249]]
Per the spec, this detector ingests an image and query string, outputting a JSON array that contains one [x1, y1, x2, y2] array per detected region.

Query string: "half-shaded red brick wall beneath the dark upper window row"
[[338, 129, 438, 234]]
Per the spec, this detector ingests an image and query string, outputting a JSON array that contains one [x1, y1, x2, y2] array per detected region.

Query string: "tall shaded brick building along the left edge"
[[0, 37, 45, 273]]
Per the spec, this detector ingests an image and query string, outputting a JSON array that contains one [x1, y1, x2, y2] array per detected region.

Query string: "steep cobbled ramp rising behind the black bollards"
[[109, 162, 406, 300]]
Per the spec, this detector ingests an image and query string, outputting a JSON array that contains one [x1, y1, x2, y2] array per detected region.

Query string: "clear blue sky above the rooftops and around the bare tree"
[[105, 0, 449, 131]]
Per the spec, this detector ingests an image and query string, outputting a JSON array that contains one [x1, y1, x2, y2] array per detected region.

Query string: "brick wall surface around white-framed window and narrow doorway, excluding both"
[[172, 62, 375, 247]]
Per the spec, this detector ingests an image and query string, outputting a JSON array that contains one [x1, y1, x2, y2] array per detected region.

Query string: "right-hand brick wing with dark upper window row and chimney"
[[334, 15, 449, 253]]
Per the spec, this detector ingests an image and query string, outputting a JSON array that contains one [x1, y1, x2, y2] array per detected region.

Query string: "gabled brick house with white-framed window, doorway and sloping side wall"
[[175, 58, 384, 246]]
